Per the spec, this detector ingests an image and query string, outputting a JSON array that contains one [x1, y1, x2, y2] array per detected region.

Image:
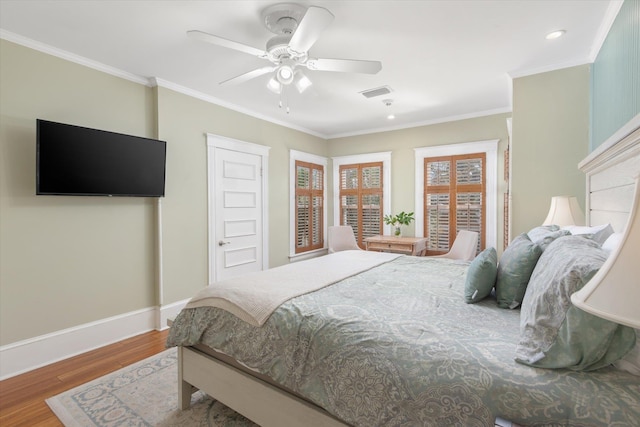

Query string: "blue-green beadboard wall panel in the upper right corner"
[[591, 0, 640, 150]]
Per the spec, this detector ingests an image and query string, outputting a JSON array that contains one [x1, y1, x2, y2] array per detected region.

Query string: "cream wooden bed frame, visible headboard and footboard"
[[178, 115, 640, 427]]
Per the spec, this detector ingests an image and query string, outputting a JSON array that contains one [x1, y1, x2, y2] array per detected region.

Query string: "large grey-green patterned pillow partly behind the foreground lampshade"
[[516, 236, 635, 370]]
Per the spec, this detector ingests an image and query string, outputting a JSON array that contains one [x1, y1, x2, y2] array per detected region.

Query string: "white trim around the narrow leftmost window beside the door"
[[289, 150, 329, 261]]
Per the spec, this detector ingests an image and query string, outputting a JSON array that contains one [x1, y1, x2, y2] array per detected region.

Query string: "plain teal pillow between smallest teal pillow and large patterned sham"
[[496, 233, 542, 308]]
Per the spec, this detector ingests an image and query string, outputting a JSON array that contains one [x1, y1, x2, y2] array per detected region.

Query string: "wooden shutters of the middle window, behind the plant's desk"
[[340, 162, 382, 248]]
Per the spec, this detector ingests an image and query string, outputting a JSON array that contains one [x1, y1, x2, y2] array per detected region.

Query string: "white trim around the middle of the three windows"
[[332, 151, 391, 234]]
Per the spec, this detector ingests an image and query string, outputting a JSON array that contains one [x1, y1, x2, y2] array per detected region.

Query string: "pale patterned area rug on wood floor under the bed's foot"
[[47, 348, 256, 427]]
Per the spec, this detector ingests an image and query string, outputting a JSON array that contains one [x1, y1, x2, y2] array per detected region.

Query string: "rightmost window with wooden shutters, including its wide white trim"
[[415, 139, 499, 253]]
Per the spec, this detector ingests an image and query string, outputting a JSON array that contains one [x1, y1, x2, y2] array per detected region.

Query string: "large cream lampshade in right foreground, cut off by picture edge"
[[571, 177, 640, 329]]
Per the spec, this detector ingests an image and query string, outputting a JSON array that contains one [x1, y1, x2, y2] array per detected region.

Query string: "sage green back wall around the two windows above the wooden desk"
[[329, 114, 511, 246]]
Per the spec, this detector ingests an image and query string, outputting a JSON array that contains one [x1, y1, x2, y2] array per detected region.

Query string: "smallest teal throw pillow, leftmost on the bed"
[[464, 248, 498, 304]]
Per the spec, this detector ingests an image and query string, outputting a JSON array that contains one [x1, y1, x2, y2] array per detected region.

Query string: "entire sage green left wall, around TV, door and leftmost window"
[[0, 40, 327, 345]]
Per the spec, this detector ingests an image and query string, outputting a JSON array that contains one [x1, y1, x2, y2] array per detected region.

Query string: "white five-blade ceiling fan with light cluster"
[[187, 3, 382, 93]]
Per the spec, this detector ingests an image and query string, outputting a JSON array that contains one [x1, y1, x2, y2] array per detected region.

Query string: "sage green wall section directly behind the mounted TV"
[[0, 40, 155, 345]]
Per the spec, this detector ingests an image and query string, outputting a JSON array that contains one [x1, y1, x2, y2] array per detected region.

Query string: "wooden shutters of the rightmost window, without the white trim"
[[423, 153, 486, 255]]
